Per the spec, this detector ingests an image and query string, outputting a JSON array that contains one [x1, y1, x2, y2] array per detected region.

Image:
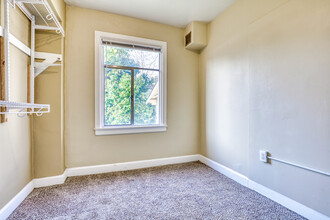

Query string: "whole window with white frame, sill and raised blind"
[[94, 31, 167, 135]]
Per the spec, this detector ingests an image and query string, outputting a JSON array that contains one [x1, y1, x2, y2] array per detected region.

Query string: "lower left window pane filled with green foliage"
[[104, 68, 131, 126]]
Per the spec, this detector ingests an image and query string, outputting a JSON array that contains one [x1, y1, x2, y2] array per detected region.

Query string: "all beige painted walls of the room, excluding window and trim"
[[0, 0, 330, 215]]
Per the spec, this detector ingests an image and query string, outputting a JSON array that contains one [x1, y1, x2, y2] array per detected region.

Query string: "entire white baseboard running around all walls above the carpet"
[[0, 154, 330, 220]]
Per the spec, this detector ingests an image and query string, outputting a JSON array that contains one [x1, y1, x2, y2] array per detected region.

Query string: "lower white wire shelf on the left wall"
[[0, 100, 50, 117]]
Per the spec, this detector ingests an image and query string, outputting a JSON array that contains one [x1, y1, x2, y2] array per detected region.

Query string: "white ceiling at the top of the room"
[[65, 0, 235, 27]]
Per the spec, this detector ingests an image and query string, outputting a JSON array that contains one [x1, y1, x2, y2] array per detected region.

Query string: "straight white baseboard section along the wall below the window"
[[66, 154, 199, 177]]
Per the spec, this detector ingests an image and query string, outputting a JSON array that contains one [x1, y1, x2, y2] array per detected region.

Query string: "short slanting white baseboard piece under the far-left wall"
[[0, 181, 34, 219]]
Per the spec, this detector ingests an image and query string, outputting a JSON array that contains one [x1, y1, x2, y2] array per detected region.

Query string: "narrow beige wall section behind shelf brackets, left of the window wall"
[[33, 0, 66, 178]]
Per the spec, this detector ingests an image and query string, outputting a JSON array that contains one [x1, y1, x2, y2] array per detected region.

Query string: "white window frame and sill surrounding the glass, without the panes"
[[94, 31, 167, 135]]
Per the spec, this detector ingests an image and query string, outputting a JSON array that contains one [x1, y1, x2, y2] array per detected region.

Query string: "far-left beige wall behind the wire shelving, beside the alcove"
[[0, 1, 32, 209]]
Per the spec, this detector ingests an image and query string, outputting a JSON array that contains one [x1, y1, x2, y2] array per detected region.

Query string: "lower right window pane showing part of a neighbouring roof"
[[134, 70, 159, 125]]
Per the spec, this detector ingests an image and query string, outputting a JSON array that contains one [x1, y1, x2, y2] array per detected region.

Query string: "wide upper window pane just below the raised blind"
[[104, 45, 160, 70]]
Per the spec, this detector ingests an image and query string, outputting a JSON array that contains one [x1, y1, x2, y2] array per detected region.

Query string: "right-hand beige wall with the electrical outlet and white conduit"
[[200, 0, 330, 216]]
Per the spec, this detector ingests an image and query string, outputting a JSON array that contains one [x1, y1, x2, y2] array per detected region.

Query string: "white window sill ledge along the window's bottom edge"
[[94, 125, 167, 136]]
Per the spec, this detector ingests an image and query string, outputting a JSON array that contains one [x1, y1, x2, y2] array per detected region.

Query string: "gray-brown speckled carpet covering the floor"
[[9, 162, 304, 219]]
